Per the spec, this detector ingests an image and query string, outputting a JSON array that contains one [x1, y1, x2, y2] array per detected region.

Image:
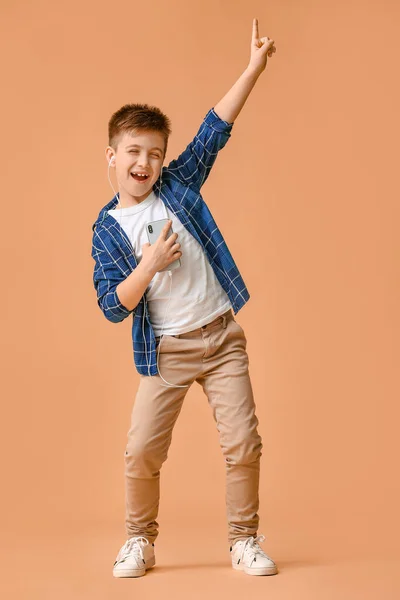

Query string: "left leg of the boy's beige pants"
[[125, 336, 198, 543]]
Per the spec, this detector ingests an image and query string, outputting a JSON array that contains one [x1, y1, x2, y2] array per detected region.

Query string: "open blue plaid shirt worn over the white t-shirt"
[[92, 108, 250, 375]]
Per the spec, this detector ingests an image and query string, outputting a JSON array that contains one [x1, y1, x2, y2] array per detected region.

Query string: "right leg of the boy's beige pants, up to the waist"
[[196, 318, 263, 545]]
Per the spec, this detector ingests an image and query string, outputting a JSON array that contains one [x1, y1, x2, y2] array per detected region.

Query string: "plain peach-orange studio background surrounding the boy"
[[1, 0, 400, 600]]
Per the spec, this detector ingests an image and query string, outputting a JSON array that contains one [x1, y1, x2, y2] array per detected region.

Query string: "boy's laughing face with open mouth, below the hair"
[[107, 130, 165, 198]]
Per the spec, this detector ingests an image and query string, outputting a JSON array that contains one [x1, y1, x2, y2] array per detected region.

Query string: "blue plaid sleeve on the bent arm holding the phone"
[[92, 232, 134, 323]]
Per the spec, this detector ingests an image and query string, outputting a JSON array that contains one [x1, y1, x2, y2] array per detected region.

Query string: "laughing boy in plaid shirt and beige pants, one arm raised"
[[92, 19, 277, 577]]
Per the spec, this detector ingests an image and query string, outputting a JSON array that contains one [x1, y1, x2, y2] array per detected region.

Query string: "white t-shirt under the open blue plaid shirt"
[[108, 191, 232, 336]]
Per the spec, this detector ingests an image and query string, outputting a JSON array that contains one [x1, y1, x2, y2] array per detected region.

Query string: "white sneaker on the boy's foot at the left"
[[113, 536, 156, 577]]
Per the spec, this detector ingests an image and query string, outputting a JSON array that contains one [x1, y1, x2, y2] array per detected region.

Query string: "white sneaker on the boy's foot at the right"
[[230, 535, 278, 575]]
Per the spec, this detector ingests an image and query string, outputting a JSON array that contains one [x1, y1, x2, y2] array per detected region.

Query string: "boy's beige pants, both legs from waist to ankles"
[[125, 310, 263, 544]]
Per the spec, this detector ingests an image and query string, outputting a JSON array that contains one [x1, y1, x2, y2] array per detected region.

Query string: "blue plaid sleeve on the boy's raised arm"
[[167, 108, 233, 191]]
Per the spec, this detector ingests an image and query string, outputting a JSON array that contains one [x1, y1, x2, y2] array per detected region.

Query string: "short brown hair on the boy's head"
[[108, 103, 171, 156]]
